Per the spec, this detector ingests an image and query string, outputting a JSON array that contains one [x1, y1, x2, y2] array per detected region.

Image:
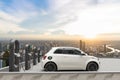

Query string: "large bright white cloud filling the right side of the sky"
[[45, 0, 120, 38]]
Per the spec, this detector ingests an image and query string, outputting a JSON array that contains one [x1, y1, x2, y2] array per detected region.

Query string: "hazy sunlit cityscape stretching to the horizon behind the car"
[[0, 40, 120, 68]]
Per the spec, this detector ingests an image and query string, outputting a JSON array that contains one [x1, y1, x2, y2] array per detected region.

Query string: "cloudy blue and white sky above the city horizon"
[[0, 0, 120, 40]]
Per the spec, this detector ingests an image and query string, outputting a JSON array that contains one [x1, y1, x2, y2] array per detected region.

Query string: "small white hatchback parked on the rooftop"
[[41, 47, 100, 71]]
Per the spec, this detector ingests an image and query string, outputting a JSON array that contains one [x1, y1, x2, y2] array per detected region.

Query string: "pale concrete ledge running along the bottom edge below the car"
[[0, 72, 120, 80]]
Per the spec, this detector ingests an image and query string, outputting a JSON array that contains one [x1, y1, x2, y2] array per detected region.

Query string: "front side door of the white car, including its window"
[[63, 49, 82, 70]]
